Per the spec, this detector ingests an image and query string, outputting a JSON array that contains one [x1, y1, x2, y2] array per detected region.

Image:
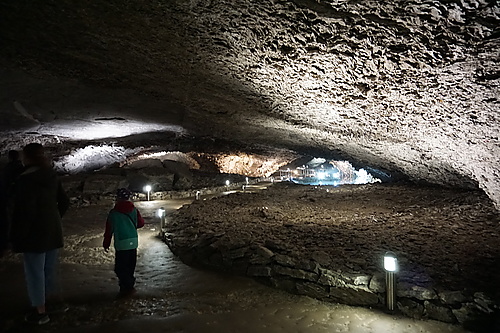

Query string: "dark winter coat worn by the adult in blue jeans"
[[11, 167, 69, 253]]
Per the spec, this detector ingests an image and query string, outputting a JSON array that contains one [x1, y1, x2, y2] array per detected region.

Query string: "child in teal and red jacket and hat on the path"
[[102, 188, 144, 296]]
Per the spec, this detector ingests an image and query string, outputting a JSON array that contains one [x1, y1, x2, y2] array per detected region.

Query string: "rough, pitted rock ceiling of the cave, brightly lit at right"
[[0, 0, 500, 208]]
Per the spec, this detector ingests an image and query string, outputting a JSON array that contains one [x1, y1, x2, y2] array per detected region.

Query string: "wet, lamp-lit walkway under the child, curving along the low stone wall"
[[0, 196, 464, 333]]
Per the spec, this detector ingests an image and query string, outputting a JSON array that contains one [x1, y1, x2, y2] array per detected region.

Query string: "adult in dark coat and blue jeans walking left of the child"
[[11, 143, 69, 325]]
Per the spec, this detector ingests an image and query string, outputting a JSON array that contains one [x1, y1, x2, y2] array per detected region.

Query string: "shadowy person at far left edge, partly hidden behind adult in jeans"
[[0, 150, 24, 257]]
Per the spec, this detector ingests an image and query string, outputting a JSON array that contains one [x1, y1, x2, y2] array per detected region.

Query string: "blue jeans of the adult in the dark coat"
[[24, 249, 59, 307]]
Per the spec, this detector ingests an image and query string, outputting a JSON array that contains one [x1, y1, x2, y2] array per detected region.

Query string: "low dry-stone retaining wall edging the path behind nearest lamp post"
[[165, 234, 498, 324]]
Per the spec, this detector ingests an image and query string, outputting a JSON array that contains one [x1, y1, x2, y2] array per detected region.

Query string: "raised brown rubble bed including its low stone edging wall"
[[166, 183, 500, 324]]
